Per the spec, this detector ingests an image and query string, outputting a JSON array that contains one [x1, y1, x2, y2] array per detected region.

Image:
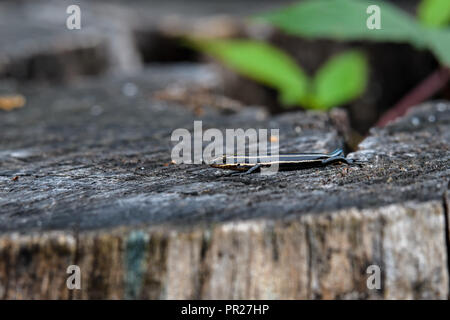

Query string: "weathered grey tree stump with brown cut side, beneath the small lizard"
[[0, 65, 450, 299]]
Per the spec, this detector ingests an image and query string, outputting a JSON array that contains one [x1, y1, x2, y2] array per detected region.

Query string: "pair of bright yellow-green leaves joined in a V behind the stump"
[[192, 39, 368, 110]]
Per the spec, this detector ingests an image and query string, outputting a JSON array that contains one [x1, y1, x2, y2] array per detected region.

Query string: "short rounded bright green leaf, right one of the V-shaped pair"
[[310, 51, 368, 110]]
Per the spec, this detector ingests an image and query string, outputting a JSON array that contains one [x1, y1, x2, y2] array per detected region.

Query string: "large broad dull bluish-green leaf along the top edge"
[[257, 0, 424, 47]]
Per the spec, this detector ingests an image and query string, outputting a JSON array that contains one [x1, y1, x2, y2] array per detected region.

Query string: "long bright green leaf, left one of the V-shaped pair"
[[191, 40, 309, 106]]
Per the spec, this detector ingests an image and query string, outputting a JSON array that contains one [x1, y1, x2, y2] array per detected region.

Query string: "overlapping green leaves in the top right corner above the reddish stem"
[[257, 0, 450, 66]]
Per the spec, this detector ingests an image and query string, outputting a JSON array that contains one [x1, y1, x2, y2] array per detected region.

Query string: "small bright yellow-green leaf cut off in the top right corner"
[[417, 0, 450, 27]]
